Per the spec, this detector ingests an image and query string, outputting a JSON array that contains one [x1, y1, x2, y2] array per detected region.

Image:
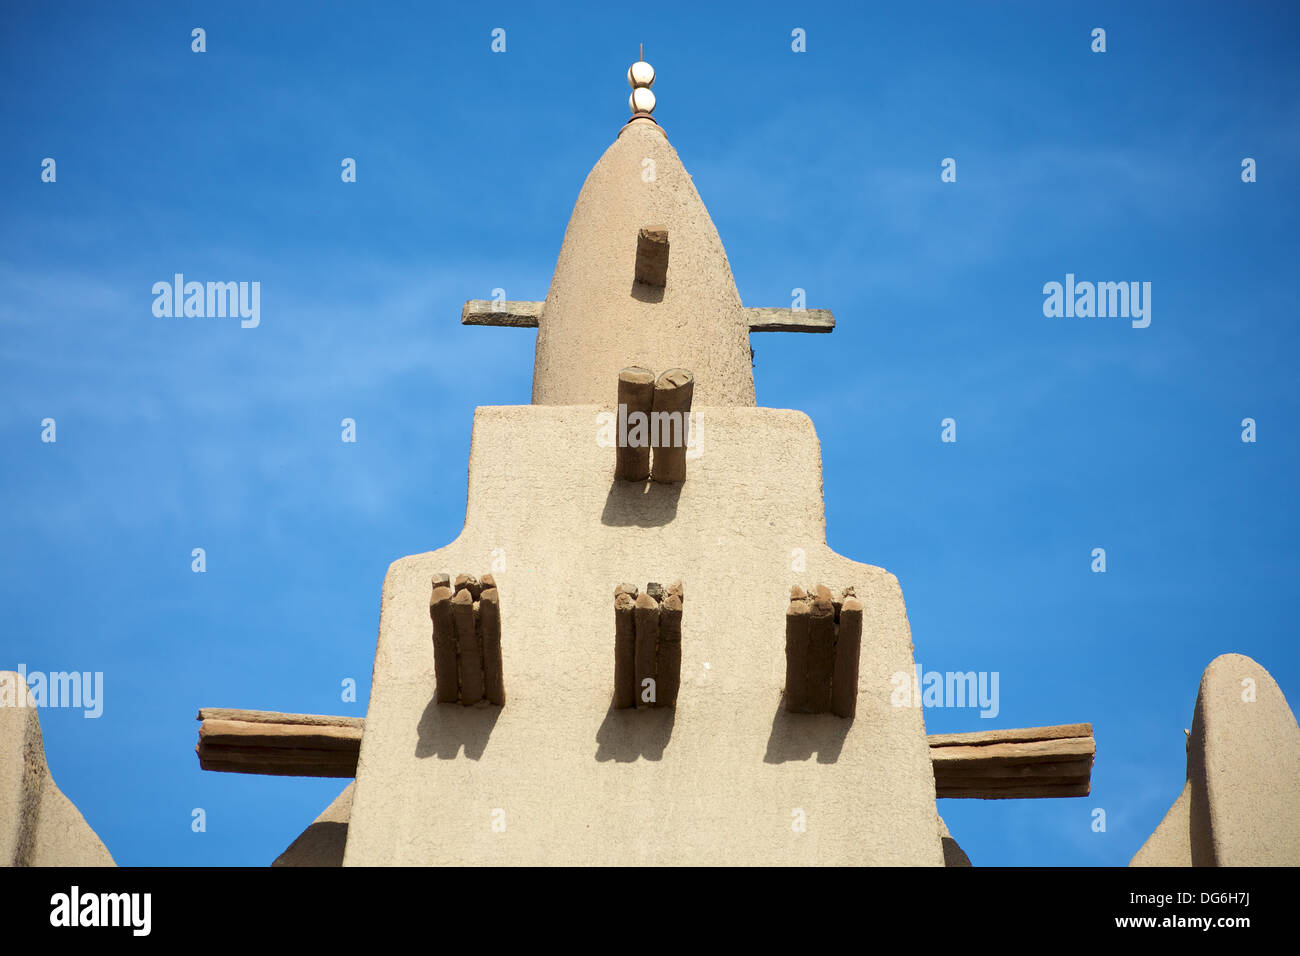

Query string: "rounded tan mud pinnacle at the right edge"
[[1131, 654, 1300, 866]]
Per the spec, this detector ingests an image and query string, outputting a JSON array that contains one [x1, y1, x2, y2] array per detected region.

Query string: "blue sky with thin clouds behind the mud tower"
[[0, 1, 1300, 865]]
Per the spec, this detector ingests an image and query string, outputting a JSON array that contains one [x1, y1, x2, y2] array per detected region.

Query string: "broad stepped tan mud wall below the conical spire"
[[345, 403, 944, 866]]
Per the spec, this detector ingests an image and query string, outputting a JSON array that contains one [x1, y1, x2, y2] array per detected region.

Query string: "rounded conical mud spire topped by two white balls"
[[533, 121, 754, 407]]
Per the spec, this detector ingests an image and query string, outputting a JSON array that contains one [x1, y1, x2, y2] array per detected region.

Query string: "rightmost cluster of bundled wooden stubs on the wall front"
[[785, 584, 862, 718]]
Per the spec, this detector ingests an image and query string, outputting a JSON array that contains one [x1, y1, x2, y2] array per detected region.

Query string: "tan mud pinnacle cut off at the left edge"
[[0, 671, 113, 866]]
